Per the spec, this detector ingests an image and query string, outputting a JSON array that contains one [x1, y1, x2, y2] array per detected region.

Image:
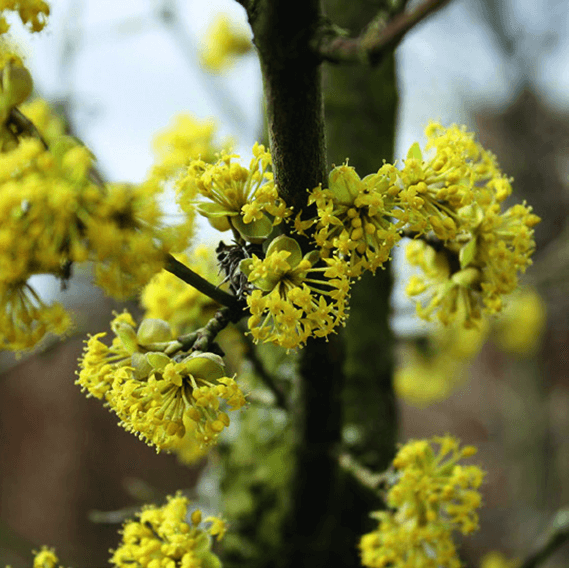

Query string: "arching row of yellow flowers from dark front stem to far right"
[[295, 123, 539, 325]]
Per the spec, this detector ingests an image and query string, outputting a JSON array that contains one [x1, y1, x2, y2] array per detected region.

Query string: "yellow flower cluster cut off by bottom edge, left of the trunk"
[[110, 495, 225, 568]]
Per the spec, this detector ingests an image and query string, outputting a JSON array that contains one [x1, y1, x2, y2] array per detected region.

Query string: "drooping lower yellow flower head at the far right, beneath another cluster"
[[407, 204, 539, 326]]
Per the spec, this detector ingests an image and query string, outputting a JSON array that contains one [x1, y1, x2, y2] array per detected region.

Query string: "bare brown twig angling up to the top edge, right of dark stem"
[[315, 0, 450, 65]]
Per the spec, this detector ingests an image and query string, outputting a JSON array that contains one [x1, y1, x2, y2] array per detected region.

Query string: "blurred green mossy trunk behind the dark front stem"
[[324, 0, 398, 566]]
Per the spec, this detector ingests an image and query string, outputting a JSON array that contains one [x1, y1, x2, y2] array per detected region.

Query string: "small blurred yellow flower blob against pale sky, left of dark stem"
[[200, 14, 253, 73]]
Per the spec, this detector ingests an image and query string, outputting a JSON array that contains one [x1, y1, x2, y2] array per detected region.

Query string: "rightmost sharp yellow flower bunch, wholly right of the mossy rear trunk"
[[399, 124, 539, 325]]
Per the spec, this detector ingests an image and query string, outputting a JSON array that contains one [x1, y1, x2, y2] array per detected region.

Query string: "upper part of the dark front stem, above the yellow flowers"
[[249, 0, 326, 211]]
